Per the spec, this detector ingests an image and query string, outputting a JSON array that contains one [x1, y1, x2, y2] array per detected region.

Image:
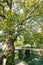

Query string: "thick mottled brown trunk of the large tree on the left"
[[3, 34, 14, 65]]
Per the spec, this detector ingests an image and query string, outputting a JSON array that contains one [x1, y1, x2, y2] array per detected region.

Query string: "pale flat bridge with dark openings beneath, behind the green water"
[[0, 47, 43, 58]]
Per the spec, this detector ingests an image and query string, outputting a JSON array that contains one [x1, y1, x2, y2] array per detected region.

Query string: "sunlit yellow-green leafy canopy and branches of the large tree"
[[0, 0, 43, 64]]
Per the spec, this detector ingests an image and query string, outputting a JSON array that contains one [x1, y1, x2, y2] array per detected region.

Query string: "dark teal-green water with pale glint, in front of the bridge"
[[25, 57, 43, 65]]
